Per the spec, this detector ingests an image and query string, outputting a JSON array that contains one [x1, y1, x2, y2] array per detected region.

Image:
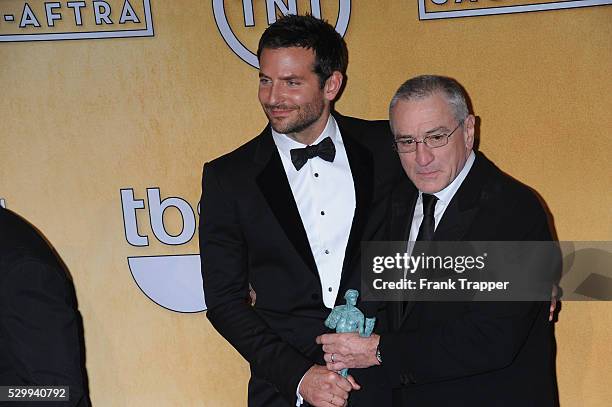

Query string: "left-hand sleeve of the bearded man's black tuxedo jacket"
[[199, 164, 313, 405]]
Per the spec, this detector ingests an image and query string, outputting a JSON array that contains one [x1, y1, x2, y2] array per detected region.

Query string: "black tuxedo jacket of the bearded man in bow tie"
[[200, 115, 401, 407]]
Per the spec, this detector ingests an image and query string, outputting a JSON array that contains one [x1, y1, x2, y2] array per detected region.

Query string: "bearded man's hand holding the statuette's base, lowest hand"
[[298, 365, 361, 407]]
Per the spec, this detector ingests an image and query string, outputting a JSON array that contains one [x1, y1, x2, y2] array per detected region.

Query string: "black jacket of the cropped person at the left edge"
[[0, 208, 89, 407]]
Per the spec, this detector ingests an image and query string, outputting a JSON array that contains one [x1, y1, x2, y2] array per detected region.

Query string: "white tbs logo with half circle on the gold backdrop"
[[121, 187, 206, 312]]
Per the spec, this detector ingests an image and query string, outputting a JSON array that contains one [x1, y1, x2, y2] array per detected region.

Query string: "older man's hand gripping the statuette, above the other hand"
[[317, 333, 380, 371]]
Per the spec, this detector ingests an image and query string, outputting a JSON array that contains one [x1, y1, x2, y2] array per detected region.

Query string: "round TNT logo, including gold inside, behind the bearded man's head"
[[213, 0, 351, 68]]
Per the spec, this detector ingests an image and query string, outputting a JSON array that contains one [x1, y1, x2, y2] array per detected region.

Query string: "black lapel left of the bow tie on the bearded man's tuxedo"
[[255, 126, 318, 278]]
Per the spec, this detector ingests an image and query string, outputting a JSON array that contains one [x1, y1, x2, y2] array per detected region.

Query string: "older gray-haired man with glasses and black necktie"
[[317, 75, 556, 407]]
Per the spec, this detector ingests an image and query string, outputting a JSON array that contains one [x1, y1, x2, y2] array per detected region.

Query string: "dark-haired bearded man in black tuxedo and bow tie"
[[200, 16, 401, 407]]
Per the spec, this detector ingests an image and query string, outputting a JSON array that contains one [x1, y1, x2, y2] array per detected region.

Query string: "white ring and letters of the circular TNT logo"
[[213, 0, 351, 69]]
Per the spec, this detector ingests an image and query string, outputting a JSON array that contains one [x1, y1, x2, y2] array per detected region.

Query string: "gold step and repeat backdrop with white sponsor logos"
[[0, 0, 612, 407]]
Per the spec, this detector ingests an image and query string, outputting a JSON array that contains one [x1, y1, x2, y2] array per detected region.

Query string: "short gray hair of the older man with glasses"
[[389, 75, 469, 122]]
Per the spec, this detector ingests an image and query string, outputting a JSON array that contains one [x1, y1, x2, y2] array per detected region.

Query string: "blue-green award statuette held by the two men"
[[325, 290, 376, 377]]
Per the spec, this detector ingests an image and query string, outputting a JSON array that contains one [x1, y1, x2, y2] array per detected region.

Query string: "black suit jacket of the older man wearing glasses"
[[380, 153, 556, 407]]
